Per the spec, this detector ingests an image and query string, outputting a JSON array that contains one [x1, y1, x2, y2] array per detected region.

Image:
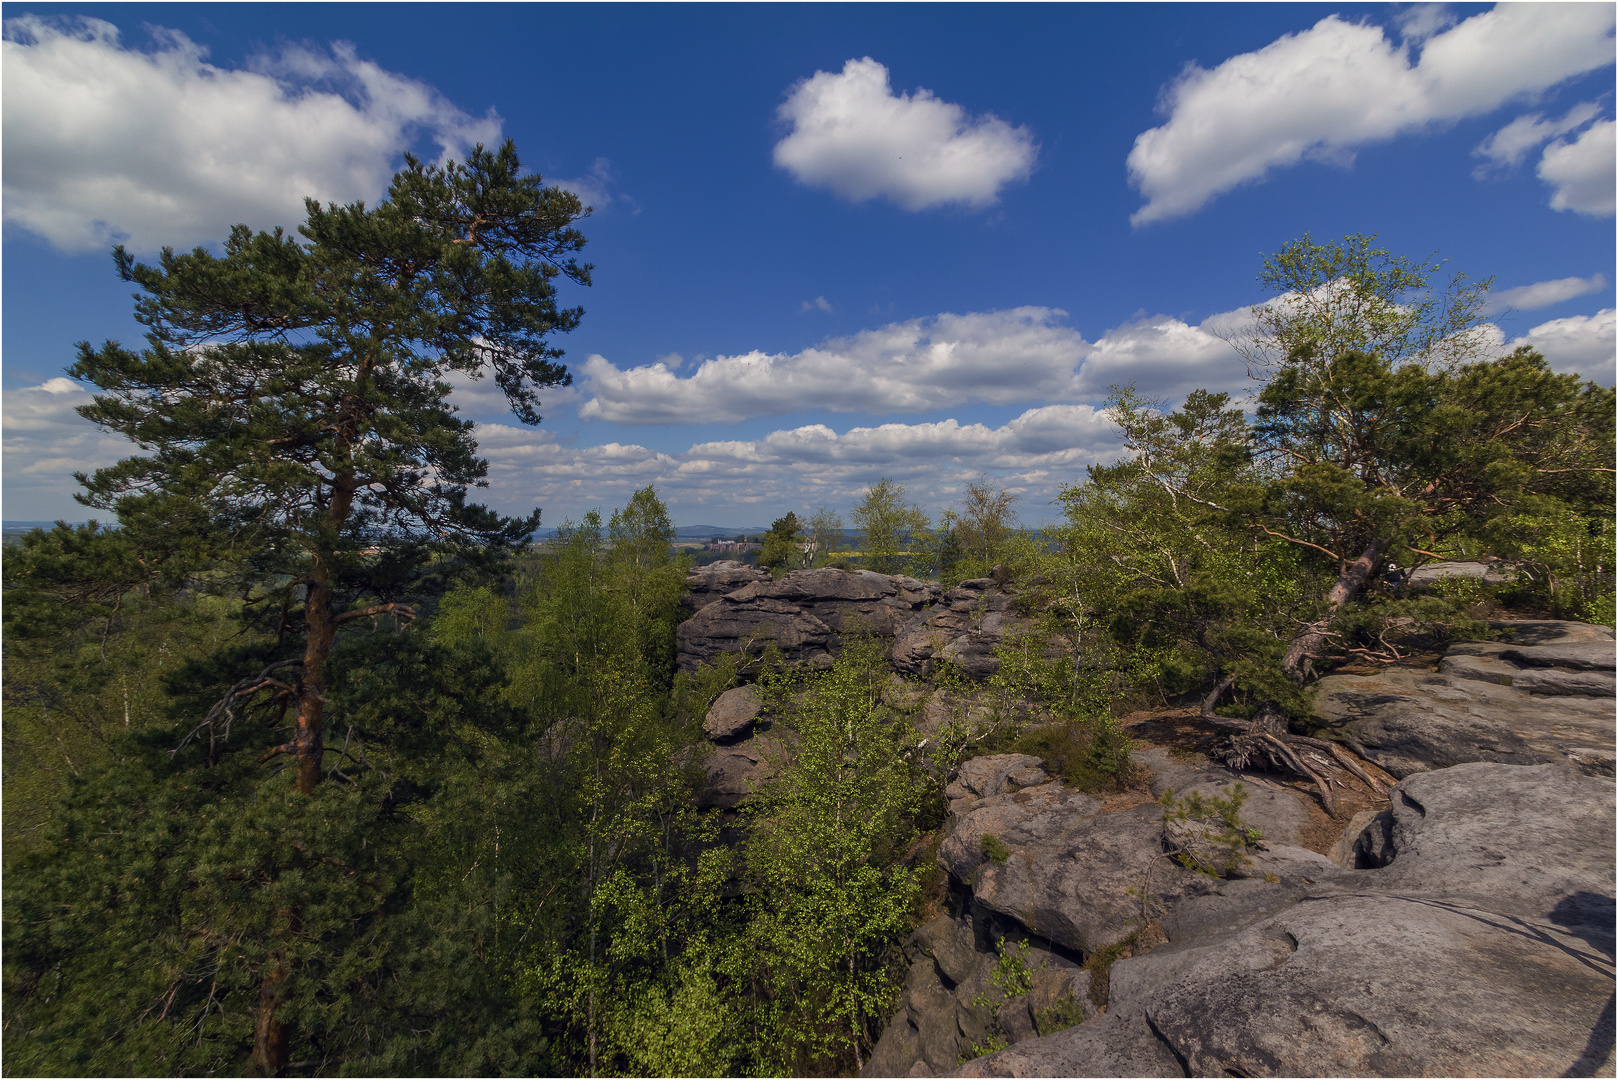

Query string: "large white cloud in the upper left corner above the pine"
[[0, 15, 500, 251]]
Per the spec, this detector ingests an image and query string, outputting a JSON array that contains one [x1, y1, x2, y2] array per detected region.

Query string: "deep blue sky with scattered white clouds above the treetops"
[[0, 3, 1615, 526]]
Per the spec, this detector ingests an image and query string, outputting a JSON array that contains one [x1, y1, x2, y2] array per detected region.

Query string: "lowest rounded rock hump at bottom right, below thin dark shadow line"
[[1141, 895, 1613, 1077]]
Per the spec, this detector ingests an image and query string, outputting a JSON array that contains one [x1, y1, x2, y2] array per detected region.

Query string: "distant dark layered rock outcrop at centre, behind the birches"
[[676, 563, 943, 670]]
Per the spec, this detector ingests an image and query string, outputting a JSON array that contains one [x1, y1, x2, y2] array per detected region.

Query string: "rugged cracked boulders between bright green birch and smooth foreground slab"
[[866, 750, 1336, 1075]]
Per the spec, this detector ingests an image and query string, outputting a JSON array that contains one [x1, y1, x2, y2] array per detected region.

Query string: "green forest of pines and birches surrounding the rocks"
[[3, 146, 1613, 1075]]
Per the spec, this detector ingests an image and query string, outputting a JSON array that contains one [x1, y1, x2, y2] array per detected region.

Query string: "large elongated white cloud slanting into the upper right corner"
[[1128, 3, 1613, 225]]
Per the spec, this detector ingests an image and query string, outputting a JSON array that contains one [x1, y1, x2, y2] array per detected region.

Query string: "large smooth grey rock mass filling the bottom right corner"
[[959, 763, 1615, 1077]]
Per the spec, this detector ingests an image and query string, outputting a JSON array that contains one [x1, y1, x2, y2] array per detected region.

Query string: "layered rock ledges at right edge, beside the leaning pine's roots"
[[1315, 620, 1615, 779]]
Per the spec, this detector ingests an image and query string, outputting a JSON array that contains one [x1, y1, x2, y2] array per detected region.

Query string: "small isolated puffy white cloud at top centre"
[[775, 57, 1039, 210]]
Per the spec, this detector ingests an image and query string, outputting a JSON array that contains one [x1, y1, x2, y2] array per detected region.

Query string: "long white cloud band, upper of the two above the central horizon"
[[579, 308, 1244, 424]]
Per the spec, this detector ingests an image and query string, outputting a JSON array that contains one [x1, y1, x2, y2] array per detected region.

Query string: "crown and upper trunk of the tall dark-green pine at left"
[[70, 142, 591, 793]]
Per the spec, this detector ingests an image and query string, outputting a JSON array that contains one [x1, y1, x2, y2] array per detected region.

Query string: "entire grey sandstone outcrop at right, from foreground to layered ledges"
[[866, 622, 1615, 1077]]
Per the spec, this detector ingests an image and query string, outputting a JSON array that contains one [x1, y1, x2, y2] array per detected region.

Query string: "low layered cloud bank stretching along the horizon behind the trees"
[[9, 299, 1618, 524]]
